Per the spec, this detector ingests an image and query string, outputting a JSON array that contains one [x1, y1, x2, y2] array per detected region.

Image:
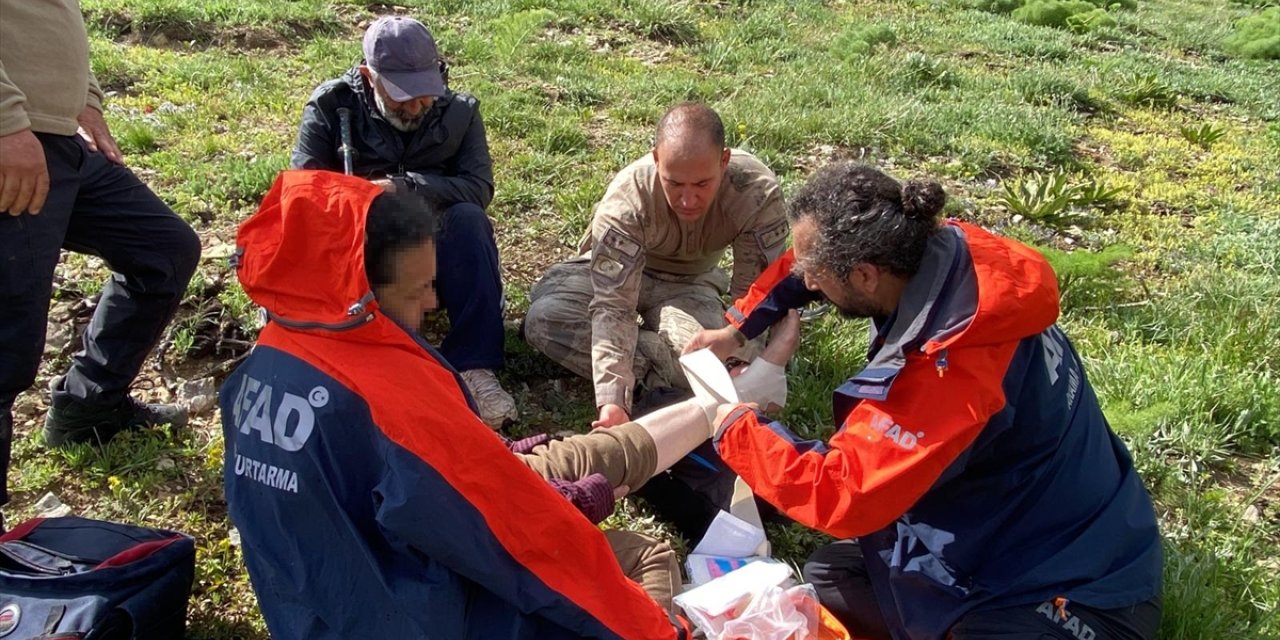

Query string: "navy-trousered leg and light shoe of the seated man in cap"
[[436, 202, 518, 428]]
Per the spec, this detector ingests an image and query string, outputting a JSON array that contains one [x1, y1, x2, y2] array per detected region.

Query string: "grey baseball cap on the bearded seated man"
[[365, 15, 444, 102]]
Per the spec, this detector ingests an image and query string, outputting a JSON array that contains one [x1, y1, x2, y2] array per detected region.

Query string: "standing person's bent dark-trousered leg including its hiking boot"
[[45, 138, 200, 444]]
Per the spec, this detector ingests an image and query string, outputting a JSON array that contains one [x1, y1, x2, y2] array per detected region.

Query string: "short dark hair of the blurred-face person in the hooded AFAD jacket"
[[365, 192, 442, 287]]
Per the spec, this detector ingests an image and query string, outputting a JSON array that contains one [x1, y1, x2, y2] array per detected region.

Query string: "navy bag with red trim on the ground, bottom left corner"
[[0, 517, 196, 640]]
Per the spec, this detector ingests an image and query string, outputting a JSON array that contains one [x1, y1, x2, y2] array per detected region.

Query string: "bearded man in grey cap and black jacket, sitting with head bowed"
[[292, 17, 517, 429]]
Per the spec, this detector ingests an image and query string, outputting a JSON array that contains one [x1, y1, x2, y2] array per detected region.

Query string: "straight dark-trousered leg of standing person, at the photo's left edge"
[[0, 133, 82, 506]]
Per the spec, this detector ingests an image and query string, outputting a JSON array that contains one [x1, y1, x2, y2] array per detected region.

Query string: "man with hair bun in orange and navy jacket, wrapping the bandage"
[[689, 164, 1161, 640]]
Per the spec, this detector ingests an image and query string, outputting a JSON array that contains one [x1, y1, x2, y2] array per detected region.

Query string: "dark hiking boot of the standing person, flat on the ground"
[[45, 380, 187, 447]]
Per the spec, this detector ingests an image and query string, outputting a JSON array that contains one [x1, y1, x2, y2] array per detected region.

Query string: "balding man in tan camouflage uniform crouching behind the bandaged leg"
[[525, 102, 788, 426]]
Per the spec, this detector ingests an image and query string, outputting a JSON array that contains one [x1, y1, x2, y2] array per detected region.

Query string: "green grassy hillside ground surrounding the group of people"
[[8, 0, 1280, 640]]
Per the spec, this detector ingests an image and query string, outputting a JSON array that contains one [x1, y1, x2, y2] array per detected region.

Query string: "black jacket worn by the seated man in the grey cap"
[[291, 68, 493, 207]]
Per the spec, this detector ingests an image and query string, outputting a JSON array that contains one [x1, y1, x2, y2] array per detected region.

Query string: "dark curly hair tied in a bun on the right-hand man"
[[787, 163, 946, 278]]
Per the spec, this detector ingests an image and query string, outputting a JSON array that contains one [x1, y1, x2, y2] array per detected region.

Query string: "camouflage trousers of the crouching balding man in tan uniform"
[[525, 260, 728, 389]]
